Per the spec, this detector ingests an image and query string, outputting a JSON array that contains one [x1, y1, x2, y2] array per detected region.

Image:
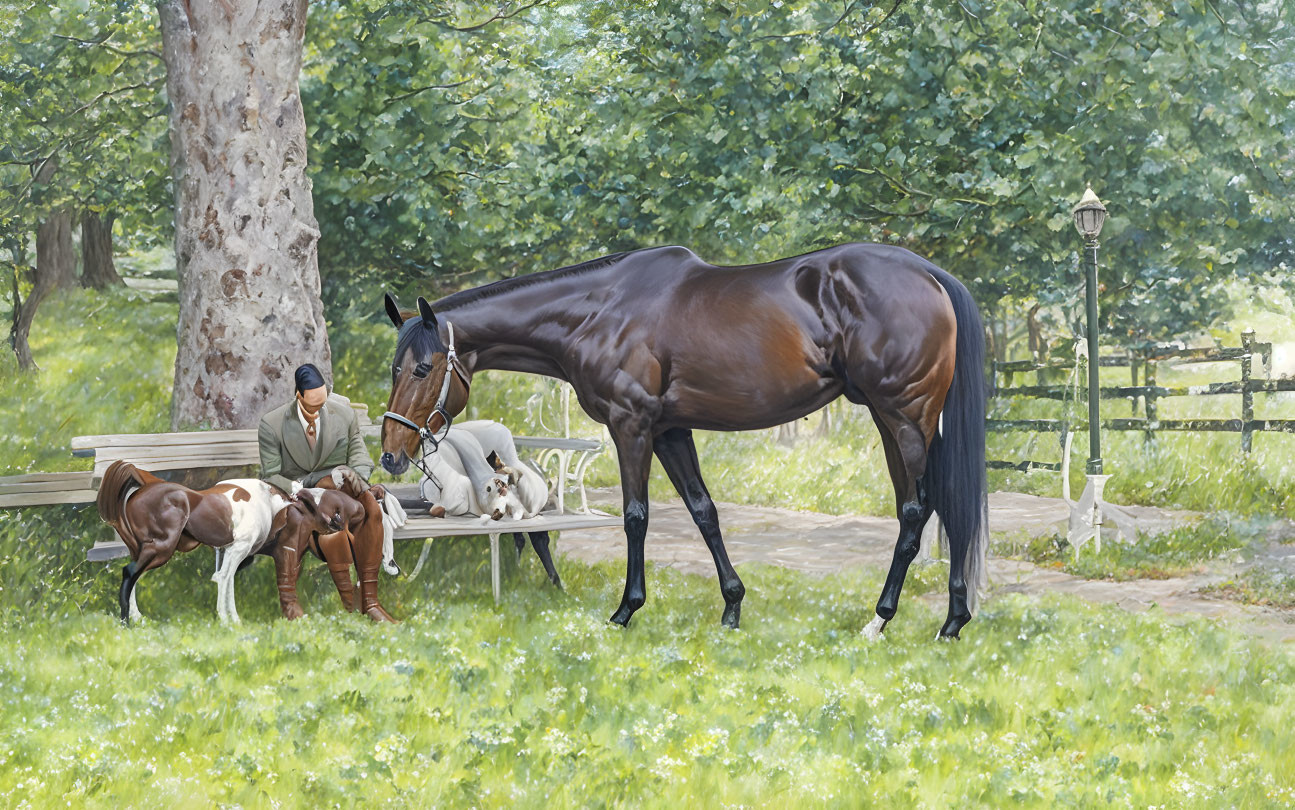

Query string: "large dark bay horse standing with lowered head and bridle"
[[382, 244, 987, 638]]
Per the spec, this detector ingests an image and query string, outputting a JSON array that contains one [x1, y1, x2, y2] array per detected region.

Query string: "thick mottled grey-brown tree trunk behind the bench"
[[158, 0, 332, 428]]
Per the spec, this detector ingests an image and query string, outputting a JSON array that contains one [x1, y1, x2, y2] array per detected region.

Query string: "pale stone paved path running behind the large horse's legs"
[[558, 489, 1295, 642]]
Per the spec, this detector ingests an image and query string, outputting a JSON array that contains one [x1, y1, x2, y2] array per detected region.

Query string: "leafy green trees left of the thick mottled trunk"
[[0, 0, 166, 368]]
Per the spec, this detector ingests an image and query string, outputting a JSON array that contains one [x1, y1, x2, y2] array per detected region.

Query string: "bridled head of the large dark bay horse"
[[382, 293, 471, 476]]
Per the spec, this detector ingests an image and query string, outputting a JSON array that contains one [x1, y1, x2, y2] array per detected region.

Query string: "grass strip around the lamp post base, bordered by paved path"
[[996, 516, 1265, 581]]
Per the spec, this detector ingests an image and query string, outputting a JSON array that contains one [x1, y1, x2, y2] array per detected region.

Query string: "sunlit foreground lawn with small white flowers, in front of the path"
[[0, 528, 1295, 807]]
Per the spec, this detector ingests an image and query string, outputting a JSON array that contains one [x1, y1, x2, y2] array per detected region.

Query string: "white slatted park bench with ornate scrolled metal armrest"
[[0, 403, 622, 603]]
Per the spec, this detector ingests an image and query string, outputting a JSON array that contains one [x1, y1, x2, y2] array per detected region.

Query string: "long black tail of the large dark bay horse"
[[923, 266, 989, 613]]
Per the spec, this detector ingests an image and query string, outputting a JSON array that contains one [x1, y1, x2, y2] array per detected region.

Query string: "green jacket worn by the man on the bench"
[[256, 397, 373, 492]]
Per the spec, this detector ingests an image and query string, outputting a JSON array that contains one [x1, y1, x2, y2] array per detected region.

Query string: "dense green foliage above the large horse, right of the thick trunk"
[[304, 0, 1295, 346]]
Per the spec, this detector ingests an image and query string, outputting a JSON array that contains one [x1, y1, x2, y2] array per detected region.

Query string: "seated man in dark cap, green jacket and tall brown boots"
[[258, 363, 395, 622]]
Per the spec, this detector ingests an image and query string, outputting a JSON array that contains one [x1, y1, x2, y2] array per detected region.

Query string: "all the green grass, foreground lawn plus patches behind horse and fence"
[[0, 265, 1295, 807]]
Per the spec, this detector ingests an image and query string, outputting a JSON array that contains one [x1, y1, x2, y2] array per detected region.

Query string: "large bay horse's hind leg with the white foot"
[[864, 408, 931, 639]]
